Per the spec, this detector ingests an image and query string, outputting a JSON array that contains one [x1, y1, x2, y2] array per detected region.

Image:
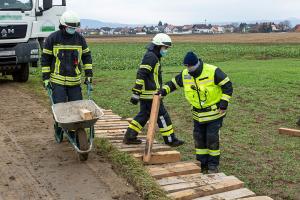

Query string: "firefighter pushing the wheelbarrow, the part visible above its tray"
[[41, 11, 93, 103]]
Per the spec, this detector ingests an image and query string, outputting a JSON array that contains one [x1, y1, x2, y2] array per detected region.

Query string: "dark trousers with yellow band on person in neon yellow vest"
[[193, 118, 223, 168]]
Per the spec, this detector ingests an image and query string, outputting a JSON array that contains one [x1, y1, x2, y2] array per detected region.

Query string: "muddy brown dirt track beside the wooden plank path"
[[0, 80, 140, 200]]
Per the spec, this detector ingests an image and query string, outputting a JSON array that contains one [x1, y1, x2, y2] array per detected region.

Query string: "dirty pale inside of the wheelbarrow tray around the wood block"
[[52, 100, 103, 123]]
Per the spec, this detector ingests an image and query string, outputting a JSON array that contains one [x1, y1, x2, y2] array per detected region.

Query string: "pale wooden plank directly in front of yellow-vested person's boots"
[[157, 173, 226, 186]]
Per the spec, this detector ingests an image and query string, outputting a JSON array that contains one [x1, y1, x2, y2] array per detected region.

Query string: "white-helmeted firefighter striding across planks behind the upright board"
[[123, 33, 184, 147]]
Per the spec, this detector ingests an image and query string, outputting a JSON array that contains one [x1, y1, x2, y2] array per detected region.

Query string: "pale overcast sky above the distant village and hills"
[[62, 0, 300, 25]]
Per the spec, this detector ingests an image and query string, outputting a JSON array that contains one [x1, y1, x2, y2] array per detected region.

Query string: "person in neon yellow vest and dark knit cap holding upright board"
[[159, 52, 233, 173]]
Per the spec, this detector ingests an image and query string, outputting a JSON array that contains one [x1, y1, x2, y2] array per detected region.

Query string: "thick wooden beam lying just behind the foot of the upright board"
[[132, 151, 180, 164]]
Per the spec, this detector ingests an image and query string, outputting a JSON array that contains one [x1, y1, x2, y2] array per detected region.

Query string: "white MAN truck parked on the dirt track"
[[0, 0, 66, 82]]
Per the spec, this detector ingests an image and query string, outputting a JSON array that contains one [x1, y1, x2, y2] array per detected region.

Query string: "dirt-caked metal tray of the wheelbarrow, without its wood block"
[[52, 100, 104, 130]]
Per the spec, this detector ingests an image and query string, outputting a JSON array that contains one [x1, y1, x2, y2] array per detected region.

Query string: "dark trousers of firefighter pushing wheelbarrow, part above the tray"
[[52, 83, 82, 104]]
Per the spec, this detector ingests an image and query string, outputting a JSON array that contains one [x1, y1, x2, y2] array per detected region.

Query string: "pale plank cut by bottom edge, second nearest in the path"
[[194, 188, 255, 200]]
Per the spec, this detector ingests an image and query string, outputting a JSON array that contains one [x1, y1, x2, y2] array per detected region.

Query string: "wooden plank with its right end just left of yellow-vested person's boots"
[[148, 163, 200, 179]]
